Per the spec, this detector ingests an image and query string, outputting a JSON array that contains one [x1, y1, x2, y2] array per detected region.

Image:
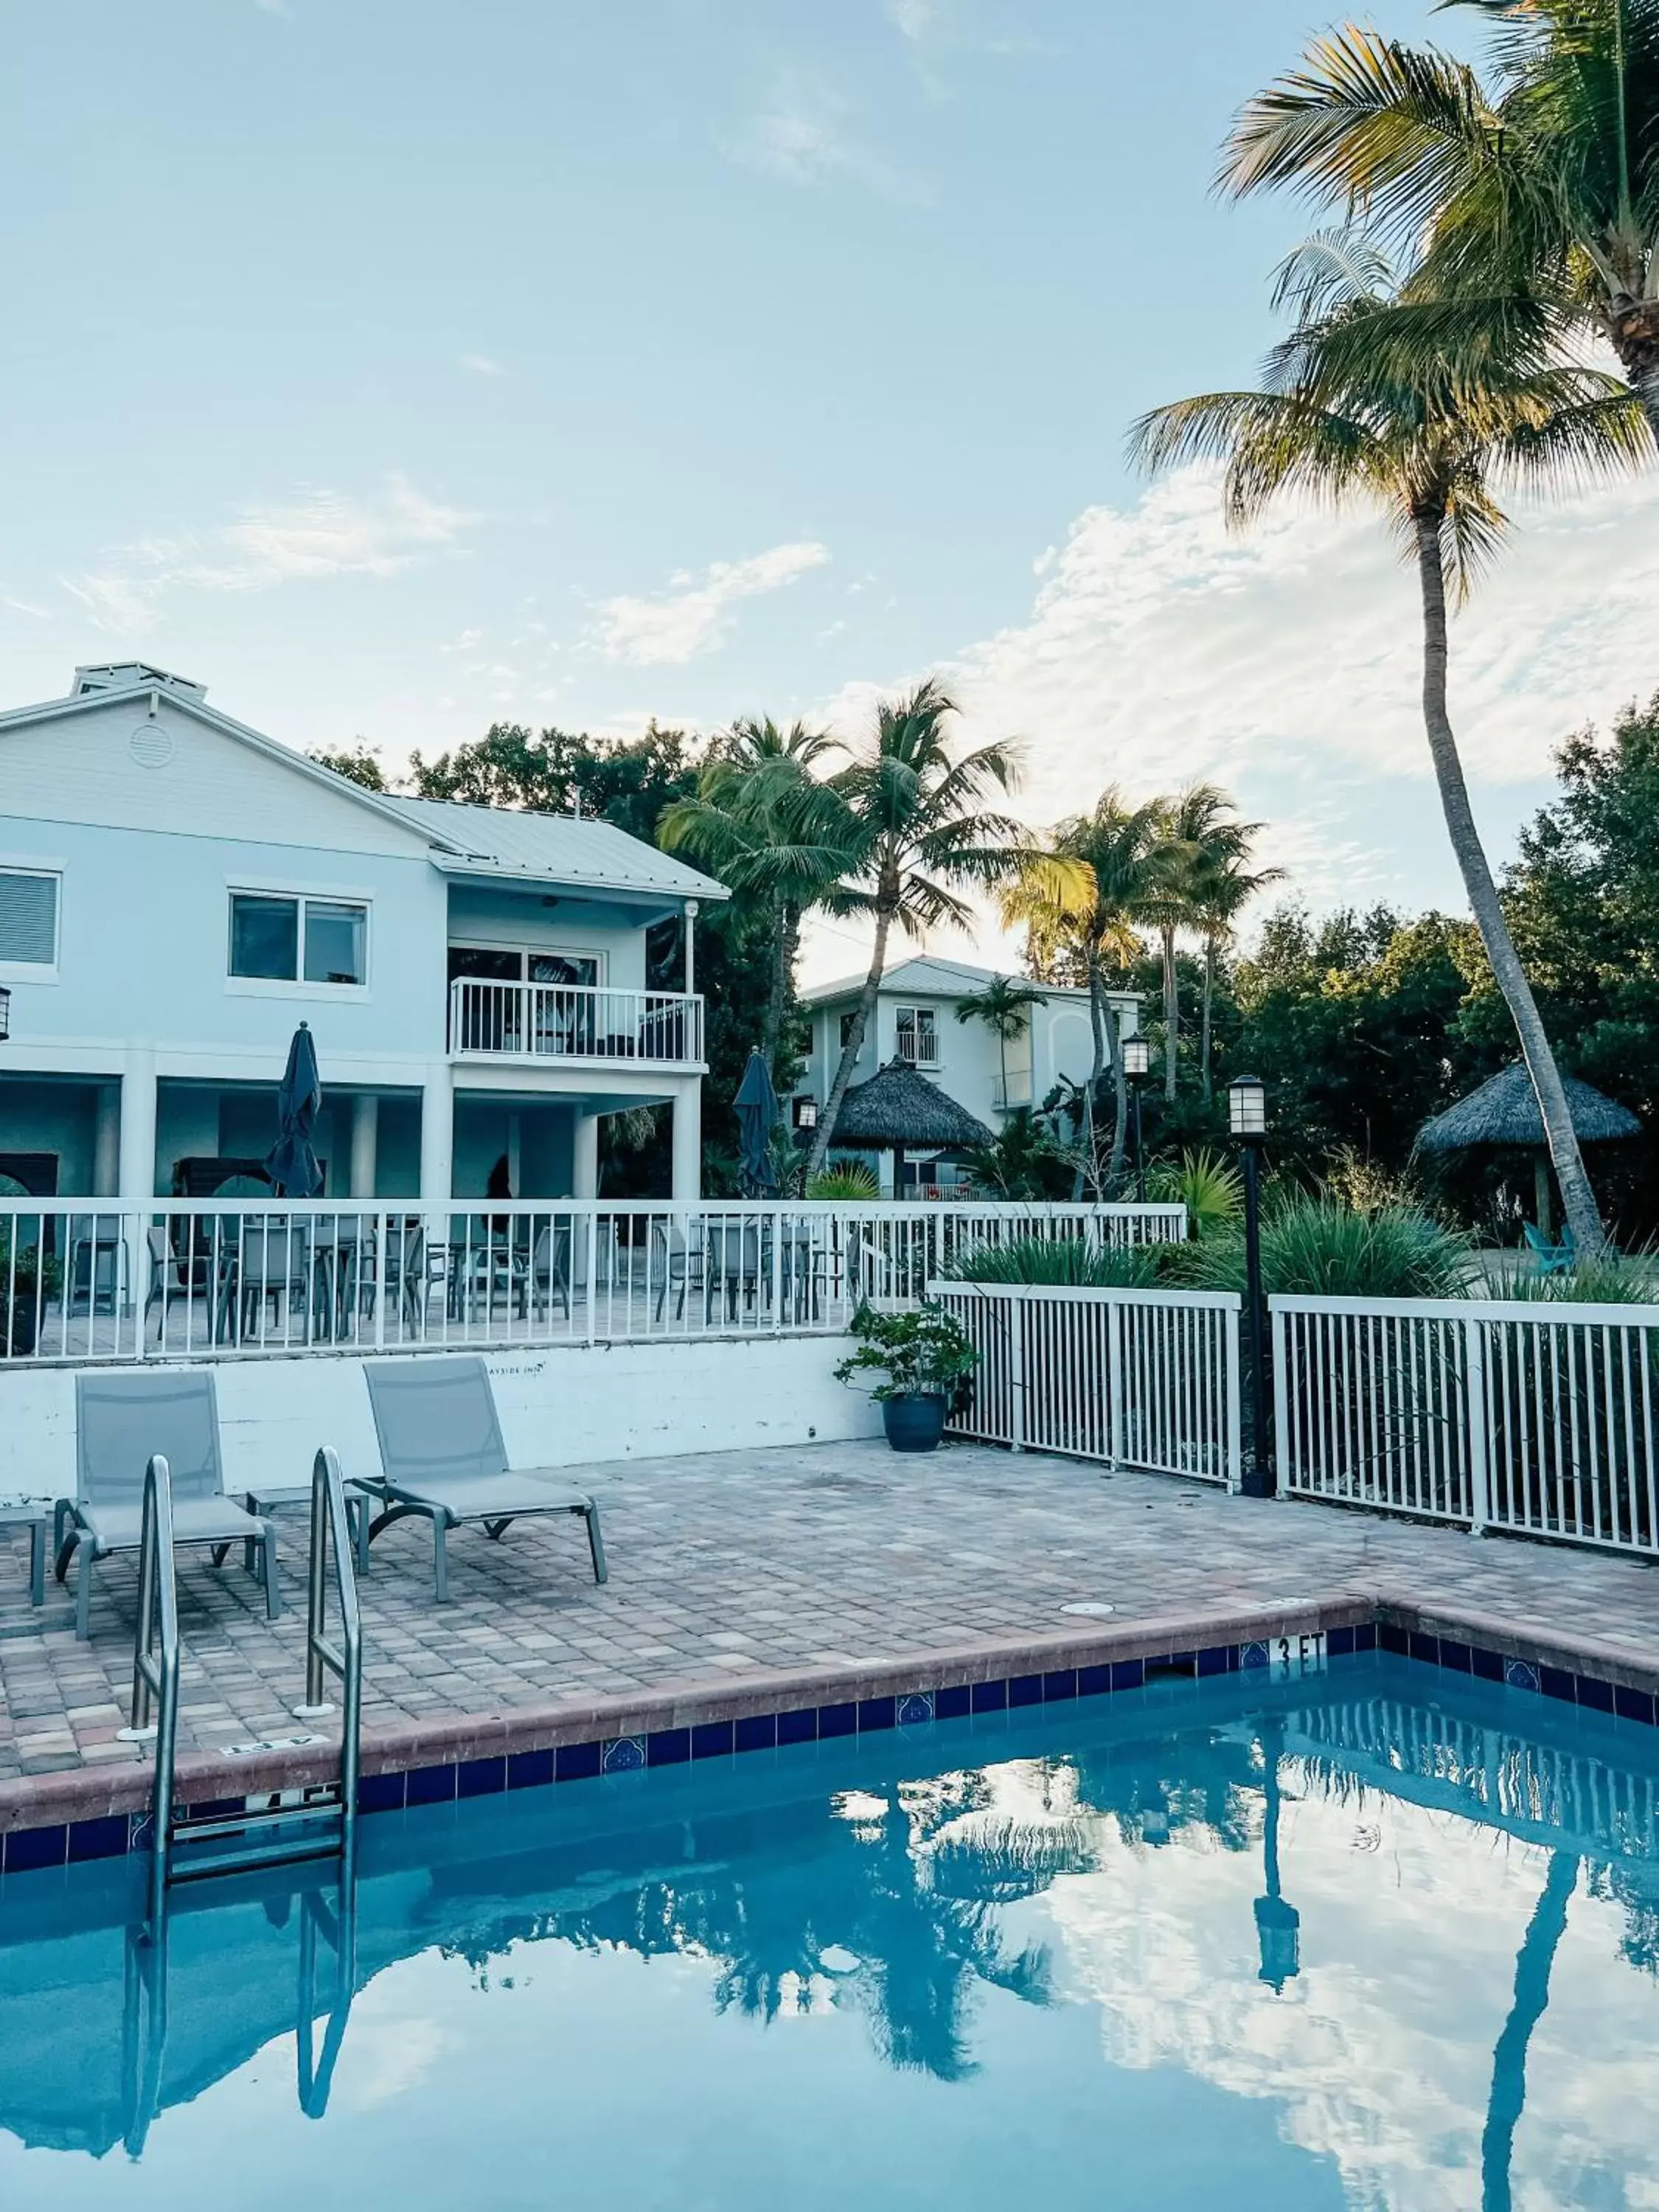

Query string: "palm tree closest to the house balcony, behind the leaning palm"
[[657, 714, 845, 1082]]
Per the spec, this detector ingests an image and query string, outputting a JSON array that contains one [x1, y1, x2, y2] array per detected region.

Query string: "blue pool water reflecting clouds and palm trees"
[[0, 1657, 1659, 2212]]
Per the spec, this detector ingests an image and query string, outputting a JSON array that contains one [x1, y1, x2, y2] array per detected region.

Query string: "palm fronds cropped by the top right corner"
[[1221, 13, 1659, 436]]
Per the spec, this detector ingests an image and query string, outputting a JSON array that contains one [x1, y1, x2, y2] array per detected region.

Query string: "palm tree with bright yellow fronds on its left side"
[[1002, 785, 1166, 1194]]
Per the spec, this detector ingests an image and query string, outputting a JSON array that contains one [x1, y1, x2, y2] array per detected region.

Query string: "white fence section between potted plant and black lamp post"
[[929, 1283, 1243, 1489]]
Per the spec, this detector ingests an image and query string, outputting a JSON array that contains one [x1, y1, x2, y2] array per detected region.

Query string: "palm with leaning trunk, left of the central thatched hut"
[[801, 677, 1022, 1181]]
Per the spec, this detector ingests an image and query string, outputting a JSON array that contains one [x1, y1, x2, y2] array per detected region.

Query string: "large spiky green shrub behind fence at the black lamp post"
[[1175, 1190, 1469, 1298]]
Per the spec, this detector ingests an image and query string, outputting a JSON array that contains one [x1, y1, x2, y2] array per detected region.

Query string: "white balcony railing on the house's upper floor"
[[449, 975, 703, 1068]]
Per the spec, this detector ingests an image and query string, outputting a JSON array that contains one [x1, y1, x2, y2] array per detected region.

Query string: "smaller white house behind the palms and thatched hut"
[[799, 956, 1139, 1181]]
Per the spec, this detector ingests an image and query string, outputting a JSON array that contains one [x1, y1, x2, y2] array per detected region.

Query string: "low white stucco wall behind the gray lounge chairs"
[[0, 1336, 880, 1504]]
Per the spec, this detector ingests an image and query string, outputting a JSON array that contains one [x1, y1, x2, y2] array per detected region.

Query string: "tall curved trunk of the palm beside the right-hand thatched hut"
[[1413, 513, 1606, 1254]]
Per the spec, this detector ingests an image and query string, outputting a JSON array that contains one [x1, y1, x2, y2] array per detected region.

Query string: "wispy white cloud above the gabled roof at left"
[[62, 473, 476, 633]]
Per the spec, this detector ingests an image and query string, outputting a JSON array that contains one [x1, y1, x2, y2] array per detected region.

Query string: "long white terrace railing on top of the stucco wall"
[[0, 1199, 1186, 1367]]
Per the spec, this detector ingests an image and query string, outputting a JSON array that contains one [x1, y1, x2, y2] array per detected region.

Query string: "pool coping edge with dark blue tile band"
[[0, 1586, 1659, 1874]]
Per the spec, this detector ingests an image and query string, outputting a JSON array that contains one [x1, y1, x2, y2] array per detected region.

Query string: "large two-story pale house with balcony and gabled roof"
[[0, 661, 728, 1199]]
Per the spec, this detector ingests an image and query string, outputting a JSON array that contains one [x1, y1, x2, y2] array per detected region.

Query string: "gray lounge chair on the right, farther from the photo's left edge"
[[354, 1356, 606, 1604]]
